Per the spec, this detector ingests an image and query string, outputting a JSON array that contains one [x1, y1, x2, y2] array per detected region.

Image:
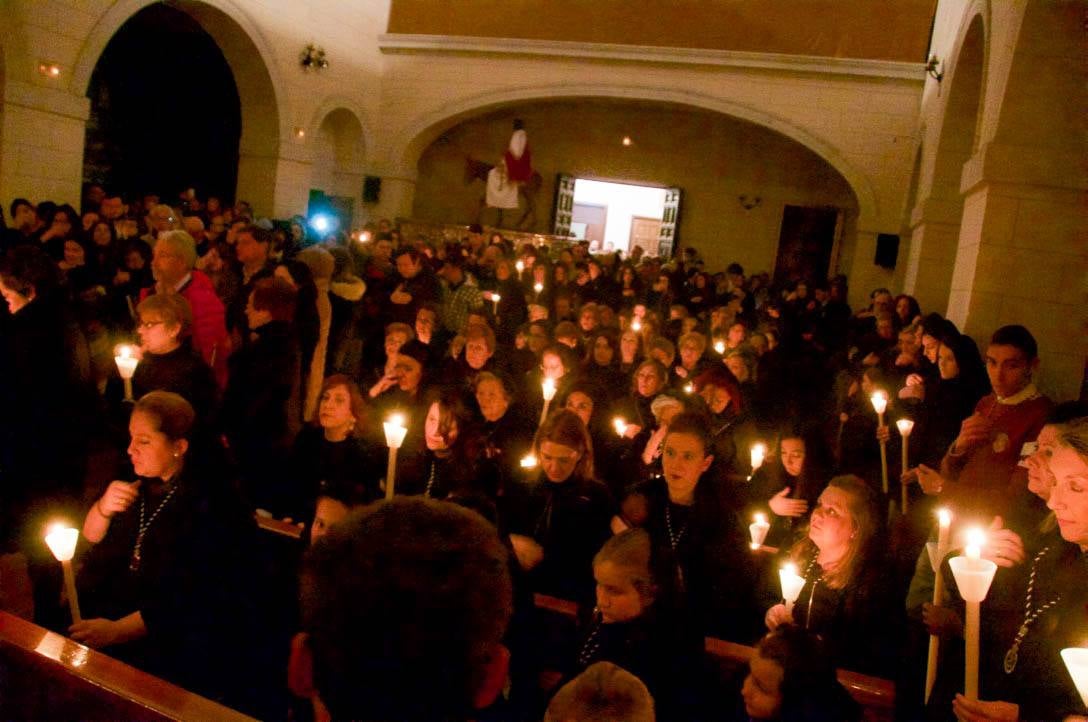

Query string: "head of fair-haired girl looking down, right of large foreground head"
[[593, 528, 658, 624]]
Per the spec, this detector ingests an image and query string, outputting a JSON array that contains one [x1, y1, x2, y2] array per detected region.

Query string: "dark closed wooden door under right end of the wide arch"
[[775, 206, 842, 284]]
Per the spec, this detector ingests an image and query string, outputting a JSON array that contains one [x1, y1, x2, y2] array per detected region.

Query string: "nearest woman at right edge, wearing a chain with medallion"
[[953, 416, 1088, 722]]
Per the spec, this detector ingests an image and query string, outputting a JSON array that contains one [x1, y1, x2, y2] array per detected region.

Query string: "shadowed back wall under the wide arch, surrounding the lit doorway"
[[412, 97, 860, 277]]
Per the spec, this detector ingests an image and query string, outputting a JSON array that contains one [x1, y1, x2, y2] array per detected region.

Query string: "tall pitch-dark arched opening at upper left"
[[84, 4, 242, 202]]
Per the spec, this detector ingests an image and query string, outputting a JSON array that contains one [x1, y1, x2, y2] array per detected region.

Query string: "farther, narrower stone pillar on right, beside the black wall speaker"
[[903, 197, 963, 314]]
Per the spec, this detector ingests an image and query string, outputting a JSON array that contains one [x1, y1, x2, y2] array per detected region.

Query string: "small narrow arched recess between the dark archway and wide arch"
[[309, 108, 366, 231]]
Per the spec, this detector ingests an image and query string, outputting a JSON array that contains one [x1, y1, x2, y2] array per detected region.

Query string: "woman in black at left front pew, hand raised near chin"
[[70, 391, 271, 707]]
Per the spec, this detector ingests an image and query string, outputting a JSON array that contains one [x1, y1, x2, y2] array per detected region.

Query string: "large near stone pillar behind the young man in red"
[[948, 146, 1088, 399]]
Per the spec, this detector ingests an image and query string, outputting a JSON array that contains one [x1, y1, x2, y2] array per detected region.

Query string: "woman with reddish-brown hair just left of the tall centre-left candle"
[[287, 374, 385, 520]]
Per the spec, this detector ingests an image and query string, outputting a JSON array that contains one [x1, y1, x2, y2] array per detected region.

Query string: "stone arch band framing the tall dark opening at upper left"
[[71, 0, 287, 213]]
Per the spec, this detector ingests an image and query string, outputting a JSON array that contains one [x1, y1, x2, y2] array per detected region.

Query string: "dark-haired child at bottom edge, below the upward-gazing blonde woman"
[[730, 624, 862, 722]]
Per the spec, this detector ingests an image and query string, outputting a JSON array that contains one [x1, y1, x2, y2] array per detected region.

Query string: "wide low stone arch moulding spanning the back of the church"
[[390, 85, 880, 225]]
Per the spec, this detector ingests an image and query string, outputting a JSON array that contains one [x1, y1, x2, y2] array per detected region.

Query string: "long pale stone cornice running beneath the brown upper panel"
[[378, 33, 926, 85]]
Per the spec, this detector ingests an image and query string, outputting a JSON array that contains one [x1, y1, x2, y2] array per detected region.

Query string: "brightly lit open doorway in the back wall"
[[570, 178, 669, 256]]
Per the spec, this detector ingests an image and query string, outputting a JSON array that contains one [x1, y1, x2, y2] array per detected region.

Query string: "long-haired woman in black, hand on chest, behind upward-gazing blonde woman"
[[749, 422, 831, 547]]
